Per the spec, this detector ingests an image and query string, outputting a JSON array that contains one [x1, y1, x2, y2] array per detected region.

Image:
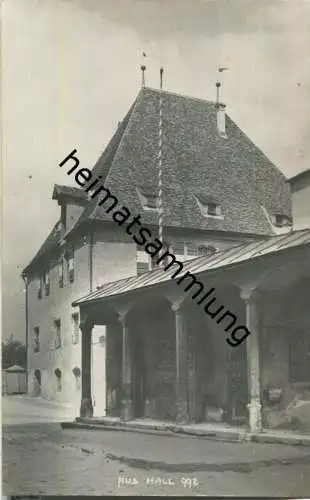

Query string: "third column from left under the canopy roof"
[[171, 303, 189, 423]]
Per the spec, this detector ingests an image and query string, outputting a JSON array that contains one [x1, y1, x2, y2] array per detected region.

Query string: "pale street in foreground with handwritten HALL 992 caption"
[[2, 397, 310, 497]]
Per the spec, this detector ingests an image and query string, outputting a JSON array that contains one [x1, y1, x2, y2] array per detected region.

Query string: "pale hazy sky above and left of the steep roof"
[[1, 0, 310, 340]]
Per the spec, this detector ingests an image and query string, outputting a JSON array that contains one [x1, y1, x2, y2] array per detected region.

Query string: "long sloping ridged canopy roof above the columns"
[[72, 229, 310, 306]]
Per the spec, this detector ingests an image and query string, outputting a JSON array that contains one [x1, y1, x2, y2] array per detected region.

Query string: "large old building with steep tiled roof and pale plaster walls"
[[23, 88, 291, 416]]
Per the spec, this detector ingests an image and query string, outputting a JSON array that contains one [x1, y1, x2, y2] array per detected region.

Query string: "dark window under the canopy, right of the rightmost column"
[[289, 330, 310, 383]]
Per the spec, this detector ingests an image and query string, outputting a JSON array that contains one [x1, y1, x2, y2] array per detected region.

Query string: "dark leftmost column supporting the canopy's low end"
[[80, 321, 93, 417]]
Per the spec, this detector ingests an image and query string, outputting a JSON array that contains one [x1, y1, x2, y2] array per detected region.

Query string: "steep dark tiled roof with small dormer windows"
[[74, 88, 290, 235]]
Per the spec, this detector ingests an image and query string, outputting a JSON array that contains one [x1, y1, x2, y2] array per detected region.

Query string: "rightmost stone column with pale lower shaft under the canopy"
[[241, 289, 262, 432]]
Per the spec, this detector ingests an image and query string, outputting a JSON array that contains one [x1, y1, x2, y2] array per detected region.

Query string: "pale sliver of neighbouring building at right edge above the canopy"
[[289, 169, 310, 229]]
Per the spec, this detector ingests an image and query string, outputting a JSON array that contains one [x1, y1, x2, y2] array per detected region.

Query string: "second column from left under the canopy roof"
[[118, 312, 133, 420]]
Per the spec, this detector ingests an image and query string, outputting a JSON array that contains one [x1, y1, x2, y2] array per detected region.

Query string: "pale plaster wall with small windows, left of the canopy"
[[28, 241, 89, 414]]
